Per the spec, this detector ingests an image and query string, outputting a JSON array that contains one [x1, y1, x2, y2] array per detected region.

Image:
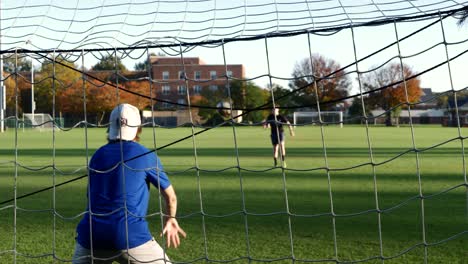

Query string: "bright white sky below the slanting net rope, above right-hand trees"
[[167, 14, 468, 93]]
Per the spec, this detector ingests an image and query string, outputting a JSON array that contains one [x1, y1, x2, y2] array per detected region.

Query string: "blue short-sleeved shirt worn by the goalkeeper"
[[77, 141, 171, 250]]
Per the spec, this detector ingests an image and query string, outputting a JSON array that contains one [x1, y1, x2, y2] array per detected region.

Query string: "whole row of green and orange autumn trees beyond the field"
[[4, 54, 421, 125]]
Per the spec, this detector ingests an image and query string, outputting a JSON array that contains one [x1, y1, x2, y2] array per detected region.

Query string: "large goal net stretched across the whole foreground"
[[0, 0, 468, 264]]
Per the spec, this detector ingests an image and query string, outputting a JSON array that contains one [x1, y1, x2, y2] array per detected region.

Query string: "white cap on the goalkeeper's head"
[[109, 104, 141, 140]]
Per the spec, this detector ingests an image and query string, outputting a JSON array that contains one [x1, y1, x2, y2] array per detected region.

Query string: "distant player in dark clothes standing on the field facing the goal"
[[263, 106, 294, 168]]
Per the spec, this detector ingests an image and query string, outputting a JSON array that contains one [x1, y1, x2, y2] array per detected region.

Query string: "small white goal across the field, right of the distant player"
[[293, 111, 343, 127]]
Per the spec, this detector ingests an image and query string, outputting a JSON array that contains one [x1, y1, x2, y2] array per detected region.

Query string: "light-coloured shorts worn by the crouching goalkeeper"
[[72, 238, 171, 264]]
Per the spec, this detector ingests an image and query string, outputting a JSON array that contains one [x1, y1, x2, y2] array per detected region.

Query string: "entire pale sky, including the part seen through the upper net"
[[0, 0, 468, 96]]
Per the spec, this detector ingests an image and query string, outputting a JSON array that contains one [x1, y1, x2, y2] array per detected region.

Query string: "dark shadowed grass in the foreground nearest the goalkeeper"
[[0, 170, 468, 263]]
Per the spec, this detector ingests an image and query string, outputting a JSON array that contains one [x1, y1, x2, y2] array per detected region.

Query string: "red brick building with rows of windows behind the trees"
[[151, 56, 244, 109]]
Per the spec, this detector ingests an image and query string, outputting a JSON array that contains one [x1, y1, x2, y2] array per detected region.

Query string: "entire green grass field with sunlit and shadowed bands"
[[0, 126, 468, 263]]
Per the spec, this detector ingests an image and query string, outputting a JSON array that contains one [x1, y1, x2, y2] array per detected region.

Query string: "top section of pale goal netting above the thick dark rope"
[[2, 0, 466, 50]]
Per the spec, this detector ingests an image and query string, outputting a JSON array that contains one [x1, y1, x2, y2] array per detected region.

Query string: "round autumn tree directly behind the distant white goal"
[[289, 54, 351, 110]]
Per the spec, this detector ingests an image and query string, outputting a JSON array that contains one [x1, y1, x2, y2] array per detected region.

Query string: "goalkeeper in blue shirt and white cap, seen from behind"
[[73, 104, 186, 264]]
